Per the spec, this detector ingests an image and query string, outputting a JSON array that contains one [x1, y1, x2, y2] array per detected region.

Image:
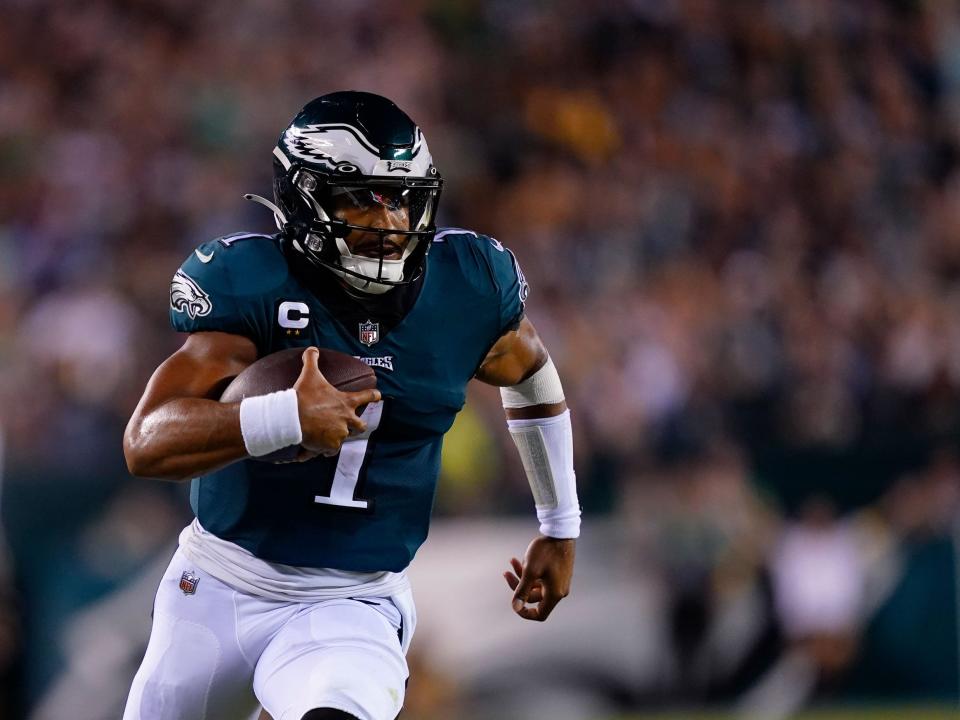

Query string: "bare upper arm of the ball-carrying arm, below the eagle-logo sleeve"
[[135, 332, 257, 415]]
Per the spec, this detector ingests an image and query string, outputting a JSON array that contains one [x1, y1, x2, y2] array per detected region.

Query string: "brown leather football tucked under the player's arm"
[[220, 347, 377, 462]]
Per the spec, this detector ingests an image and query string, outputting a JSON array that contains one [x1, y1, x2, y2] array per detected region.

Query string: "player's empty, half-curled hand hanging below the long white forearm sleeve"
[[503, 535, 577, 622]]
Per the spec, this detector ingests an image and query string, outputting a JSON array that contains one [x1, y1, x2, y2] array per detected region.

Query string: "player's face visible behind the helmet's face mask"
[[333, 188, 410, 260]]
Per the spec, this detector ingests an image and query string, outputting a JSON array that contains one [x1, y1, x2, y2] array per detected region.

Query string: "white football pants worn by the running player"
[[123, 550, 416, 720]]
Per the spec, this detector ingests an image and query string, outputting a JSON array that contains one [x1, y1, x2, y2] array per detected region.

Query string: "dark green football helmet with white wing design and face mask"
[[246, 91, 443, 294]]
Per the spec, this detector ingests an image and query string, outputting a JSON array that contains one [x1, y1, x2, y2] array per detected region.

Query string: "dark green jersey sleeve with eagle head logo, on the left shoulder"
[[170, 235, 264, 338]]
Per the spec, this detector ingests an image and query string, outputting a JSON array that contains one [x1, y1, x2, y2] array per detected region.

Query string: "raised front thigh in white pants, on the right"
[[254, 598, 408, 720]]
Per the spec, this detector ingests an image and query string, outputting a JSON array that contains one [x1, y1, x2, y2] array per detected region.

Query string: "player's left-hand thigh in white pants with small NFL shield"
[[123, 551, 259, 720]]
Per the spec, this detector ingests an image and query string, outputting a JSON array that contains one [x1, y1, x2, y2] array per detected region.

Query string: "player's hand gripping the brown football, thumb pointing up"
[[293, 347, 380, 460]]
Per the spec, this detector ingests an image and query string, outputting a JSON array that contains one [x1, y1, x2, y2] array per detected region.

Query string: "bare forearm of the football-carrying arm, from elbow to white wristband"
[[123, 398, 247, 481]]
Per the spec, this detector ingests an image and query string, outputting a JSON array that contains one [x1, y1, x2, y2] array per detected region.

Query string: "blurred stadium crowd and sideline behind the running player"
[[0, 0, 960, 720]]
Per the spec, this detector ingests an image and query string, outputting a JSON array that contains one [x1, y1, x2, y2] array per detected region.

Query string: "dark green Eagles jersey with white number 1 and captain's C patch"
[[170, 229, 527, 572]]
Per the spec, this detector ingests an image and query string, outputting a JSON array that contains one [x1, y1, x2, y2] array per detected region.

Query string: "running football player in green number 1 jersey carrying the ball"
[[124, 92, 580, 720]]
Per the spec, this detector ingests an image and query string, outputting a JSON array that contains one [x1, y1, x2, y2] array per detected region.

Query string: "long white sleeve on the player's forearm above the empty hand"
[[507, 410, 580, 538]]
